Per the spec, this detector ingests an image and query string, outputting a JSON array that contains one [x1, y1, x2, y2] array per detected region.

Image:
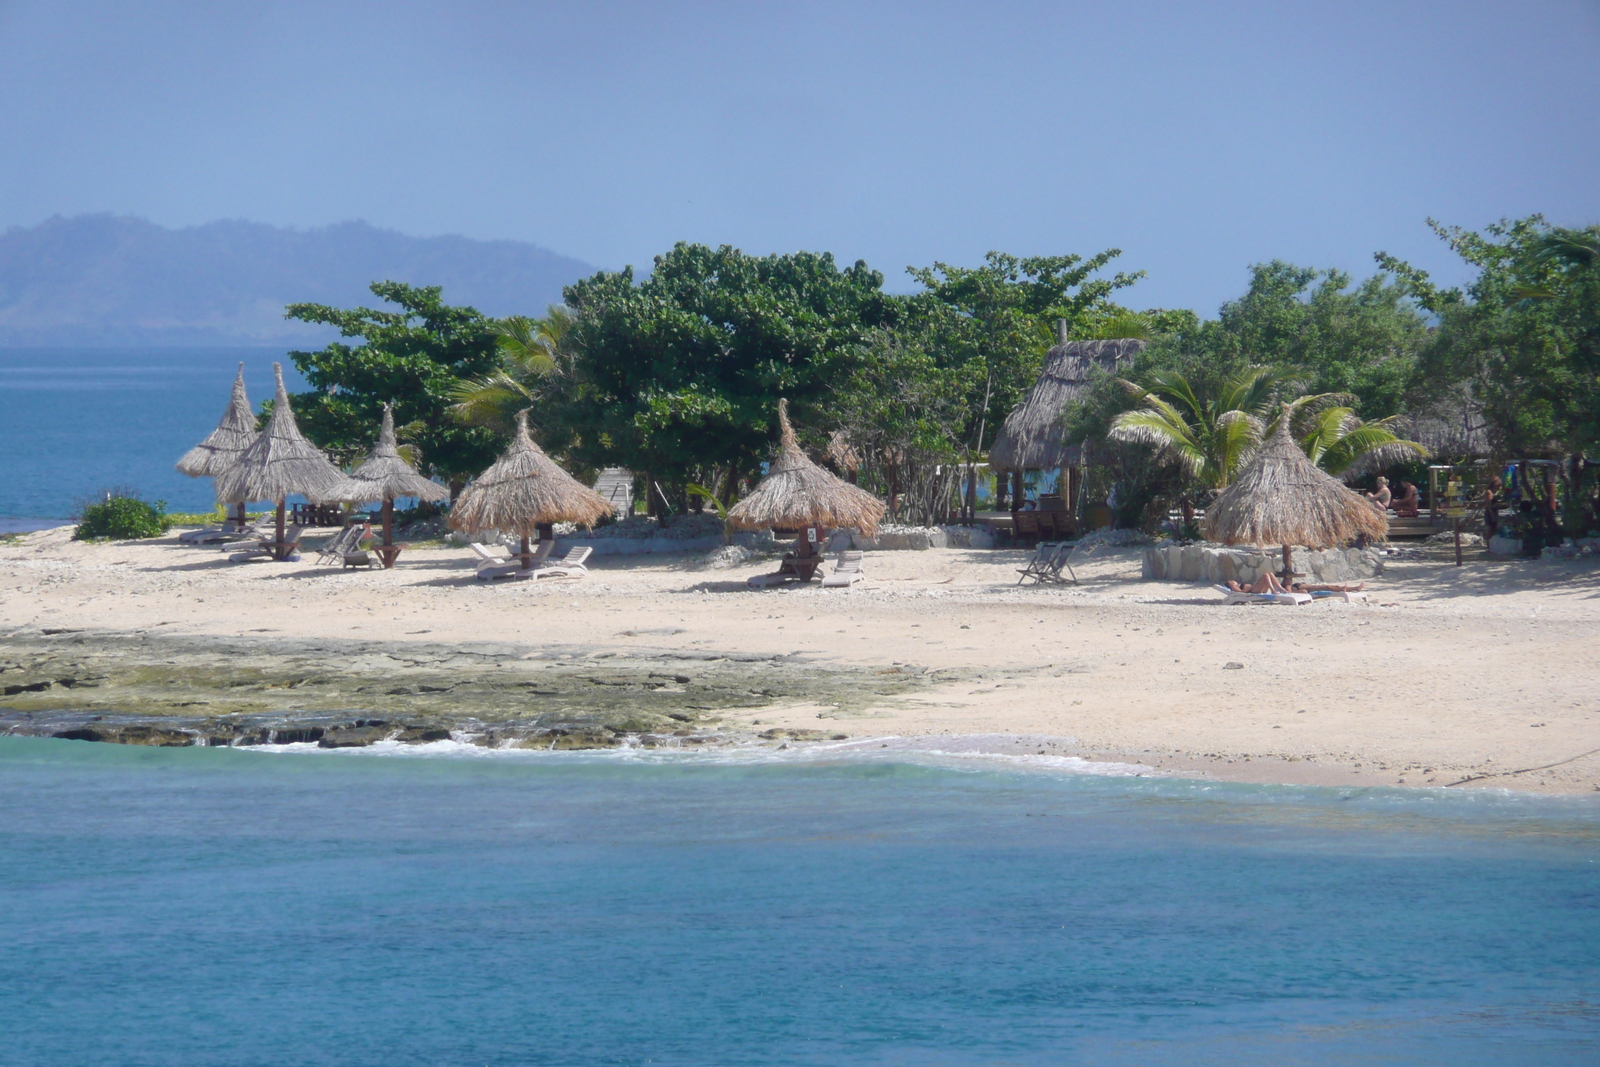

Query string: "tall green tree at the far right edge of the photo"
[[1378, 214, 1600, 456]]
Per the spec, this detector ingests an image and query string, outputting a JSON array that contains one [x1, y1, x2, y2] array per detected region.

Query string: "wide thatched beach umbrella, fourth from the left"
[[450, 410, 613, 566]]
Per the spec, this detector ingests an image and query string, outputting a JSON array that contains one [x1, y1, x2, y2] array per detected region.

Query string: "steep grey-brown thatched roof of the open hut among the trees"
[[989, 339, 1146, 470]]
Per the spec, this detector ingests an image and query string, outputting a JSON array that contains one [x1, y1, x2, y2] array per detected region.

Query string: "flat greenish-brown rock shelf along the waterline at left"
[[0, 629, 950, 750]]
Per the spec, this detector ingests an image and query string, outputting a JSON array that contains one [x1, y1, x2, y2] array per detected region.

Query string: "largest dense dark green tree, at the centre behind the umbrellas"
[[565, 243, 898, 501]]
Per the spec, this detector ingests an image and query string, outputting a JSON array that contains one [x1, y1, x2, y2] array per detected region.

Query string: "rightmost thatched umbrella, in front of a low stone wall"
[[1205, 406, 1389, 581]]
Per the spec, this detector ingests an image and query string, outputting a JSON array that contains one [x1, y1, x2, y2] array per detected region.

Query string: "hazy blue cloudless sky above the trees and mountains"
[[0, 0, 1600, 314]]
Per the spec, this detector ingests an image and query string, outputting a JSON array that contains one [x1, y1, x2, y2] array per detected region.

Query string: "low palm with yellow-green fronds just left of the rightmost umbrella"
[[1110, 366, 1288, 490]]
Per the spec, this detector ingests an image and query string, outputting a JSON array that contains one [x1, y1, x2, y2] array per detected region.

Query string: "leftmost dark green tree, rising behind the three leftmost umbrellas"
[[285, 282, 501, 491]]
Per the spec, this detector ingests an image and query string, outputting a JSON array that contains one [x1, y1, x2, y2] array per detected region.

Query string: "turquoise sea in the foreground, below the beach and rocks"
[[0, 739, 1600, 1067]]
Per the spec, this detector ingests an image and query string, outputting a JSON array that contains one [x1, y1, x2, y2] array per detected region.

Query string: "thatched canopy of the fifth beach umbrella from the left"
[[728, 400, 888, 537]]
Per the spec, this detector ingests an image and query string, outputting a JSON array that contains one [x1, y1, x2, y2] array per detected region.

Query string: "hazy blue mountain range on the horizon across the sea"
[[0, 214, 595, 346]]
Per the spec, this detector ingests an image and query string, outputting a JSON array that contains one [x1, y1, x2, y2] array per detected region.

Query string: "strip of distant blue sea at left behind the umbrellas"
[[0, 347, 306, 533]]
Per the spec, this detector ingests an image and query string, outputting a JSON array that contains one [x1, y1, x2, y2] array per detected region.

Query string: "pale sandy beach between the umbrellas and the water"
[[0, 528, 1600, 793]]
